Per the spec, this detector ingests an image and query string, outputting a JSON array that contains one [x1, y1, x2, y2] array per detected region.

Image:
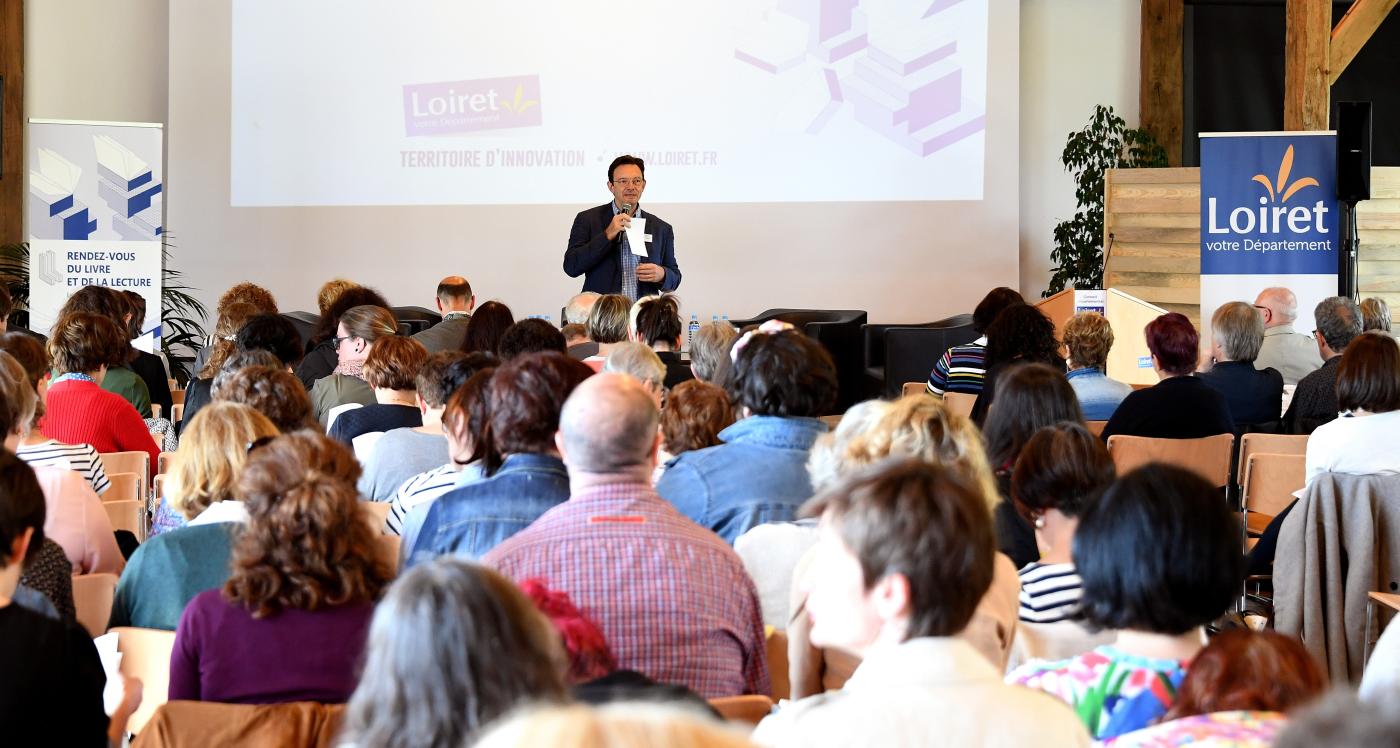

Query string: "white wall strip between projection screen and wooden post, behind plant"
[[1021, 0, 1141, 298]]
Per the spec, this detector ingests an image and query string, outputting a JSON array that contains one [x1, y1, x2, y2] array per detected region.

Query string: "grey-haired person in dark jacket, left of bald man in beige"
[[1197, 301, 1284, 431]]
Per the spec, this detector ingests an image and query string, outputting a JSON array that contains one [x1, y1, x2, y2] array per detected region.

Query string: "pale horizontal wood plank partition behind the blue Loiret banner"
[[1103, 167, 1400, 324]]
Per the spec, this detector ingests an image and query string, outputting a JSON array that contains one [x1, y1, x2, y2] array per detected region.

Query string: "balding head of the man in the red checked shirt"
[[559, 373, 661, 473]]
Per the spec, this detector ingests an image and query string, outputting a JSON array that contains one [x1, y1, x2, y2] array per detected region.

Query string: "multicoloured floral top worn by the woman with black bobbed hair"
[[1007, 646, 1190, 740]]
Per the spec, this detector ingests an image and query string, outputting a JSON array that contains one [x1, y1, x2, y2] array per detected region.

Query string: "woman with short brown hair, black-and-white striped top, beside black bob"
[[1011, 422, 1114, 623]]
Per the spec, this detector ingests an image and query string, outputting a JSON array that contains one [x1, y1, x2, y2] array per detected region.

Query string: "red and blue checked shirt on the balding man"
[[483, 482, 770, 699]]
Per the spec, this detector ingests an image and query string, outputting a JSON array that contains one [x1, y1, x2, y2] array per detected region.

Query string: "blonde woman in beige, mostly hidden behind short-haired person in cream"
[[784, 395, 1021, 696]]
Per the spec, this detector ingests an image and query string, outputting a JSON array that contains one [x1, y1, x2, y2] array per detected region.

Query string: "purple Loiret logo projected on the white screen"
[[403, 76, 543, 136]]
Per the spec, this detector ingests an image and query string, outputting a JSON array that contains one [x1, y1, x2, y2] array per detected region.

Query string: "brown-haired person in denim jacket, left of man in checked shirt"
[[407, 353, 592, 565]]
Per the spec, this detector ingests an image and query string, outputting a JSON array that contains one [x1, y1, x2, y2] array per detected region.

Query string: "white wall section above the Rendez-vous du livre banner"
[[24, 0, 169, 123]]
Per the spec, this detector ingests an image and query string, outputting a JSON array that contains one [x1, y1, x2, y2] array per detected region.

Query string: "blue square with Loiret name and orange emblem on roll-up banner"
[[1201, 137, 1337, 273]]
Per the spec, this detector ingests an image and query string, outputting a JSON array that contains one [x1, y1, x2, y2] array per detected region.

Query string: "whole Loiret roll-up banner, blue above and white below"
[[1201, 132, 1341, 346]]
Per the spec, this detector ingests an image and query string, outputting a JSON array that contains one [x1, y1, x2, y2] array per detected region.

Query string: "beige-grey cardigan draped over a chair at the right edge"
[[1274, 472, 1400, 684]]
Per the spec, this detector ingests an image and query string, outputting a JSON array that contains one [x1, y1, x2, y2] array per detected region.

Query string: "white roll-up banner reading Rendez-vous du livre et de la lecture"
[[25, 119, 165, 352]]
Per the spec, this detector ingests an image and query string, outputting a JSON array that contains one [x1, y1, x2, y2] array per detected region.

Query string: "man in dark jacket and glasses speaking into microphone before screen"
[[564, 155, 680, 301]]
